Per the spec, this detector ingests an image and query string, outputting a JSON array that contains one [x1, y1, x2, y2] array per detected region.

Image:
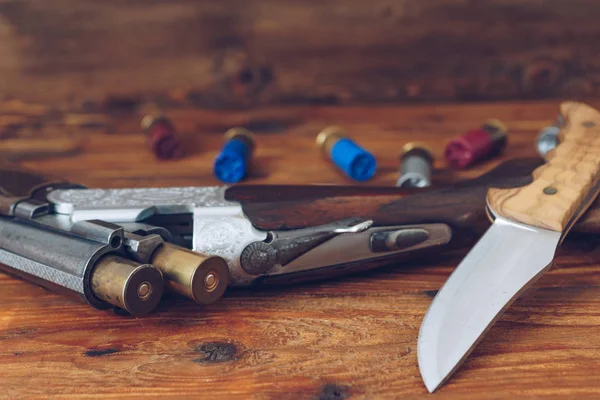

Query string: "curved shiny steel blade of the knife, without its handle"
[[417, 217, 561, 392]]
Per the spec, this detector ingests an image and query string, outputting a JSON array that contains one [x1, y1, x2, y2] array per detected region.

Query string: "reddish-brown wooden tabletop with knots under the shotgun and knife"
[[0, 101, 600, 399]]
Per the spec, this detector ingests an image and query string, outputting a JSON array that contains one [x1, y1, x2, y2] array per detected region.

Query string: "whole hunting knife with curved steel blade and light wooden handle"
[[417, 102, 600, 392]]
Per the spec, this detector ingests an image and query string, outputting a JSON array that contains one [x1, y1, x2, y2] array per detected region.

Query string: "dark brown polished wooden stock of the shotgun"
[[226, 158, 600, 238]]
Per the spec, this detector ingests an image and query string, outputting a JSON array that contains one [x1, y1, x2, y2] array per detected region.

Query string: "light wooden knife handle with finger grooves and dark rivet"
[[487, 102, 600, 233]]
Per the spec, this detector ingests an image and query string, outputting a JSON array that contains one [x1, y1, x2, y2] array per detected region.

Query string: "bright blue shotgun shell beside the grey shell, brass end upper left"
[[317, 126, 377, 181]]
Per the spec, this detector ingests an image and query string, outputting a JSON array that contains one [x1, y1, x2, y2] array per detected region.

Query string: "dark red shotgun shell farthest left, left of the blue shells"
[[141, 115, 183, 160]]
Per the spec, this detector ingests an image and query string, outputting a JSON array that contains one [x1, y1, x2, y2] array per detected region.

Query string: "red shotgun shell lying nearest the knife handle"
[[444, 120, 507, 169]]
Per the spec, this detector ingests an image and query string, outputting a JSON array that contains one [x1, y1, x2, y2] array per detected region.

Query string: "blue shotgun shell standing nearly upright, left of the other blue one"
[[213, 128, 254, 183]]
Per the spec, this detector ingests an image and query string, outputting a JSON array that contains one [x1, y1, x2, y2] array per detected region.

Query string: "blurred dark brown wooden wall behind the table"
[[0, 0, 600, 109]]
